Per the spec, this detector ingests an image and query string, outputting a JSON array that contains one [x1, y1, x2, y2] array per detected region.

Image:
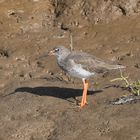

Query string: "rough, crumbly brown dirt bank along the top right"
[[51, 0, 140, 29]]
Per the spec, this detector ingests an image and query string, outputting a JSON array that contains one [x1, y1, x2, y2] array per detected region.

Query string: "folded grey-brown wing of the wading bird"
[[66, 52, 119, 73]]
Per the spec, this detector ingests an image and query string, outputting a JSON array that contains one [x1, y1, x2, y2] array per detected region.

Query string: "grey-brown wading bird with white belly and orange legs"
[[49, 46, 125, 107]]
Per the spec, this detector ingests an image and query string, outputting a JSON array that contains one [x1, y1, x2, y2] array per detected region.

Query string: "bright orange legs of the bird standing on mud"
[[80, 79, 88, 108]]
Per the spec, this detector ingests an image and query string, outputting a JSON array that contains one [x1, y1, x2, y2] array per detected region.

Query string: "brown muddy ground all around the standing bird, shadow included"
[[0, 0, 140, 140]]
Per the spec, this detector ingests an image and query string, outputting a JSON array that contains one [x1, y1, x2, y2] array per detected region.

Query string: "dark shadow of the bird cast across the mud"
[[8, 87, 102, 100]]
